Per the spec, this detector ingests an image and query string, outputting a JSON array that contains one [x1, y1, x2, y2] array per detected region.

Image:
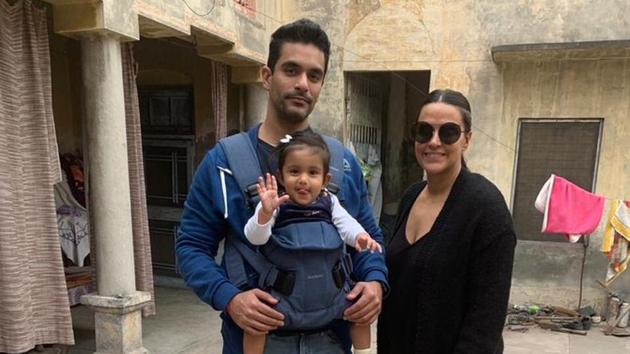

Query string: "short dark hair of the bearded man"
[[267, 18, 330, 73]]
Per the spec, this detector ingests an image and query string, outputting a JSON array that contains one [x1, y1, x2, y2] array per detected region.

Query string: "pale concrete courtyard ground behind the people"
[[60, 287, 630, 354]]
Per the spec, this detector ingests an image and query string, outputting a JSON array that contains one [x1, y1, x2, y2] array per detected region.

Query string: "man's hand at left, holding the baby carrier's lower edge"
[[225, 289, 284, 335]]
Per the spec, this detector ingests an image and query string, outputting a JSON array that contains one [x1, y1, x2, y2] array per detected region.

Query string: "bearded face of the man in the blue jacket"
[[262, 43, 325, 124]]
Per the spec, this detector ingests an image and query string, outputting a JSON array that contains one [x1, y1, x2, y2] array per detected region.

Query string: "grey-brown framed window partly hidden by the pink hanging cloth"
[[512, 119, 603, 242]]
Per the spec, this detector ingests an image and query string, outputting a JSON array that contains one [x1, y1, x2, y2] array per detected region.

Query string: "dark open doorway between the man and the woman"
[[345, 71, 431, 239]]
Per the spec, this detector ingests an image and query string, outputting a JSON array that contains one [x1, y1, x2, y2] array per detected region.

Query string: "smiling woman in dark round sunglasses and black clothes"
[[378, 90, 516, 354]]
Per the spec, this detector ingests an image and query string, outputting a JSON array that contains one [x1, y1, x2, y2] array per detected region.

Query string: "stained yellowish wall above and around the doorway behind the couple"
[[283, 0, 630, 197]]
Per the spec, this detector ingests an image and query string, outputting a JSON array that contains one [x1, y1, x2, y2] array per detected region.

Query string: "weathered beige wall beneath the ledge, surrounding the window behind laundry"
[[501, 59, 630, 306]]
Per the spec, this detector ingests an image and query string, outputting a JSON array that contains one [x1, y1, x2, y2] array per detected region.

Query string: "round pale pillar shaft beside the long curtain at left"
[[81, 35, 136, 296]]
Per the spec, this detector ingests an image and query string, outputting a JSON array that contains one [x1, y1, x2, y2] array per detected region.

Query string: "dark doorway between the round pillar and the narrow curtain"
[[139, 87, 195, 276]]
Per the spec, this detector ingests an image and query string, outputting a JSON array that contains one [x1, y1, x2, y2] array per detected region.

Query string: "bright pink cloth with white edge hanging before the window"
[[535, 174, 606, 242]]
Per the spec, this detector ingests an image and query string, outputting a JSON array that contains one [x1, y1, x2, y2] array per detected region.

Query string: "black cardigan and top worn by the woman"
[[377, 170, 516, 354]]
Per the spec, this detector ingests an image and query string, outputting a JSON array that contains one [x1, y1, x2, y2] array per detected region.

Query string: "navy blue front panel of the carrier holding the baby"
[[260, 220, 352, 330]]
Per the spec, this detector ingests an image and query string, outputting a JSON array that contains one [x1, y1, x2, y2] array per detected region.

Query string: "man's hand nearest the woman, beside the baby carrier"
[[343, 281, 383, 326]]
